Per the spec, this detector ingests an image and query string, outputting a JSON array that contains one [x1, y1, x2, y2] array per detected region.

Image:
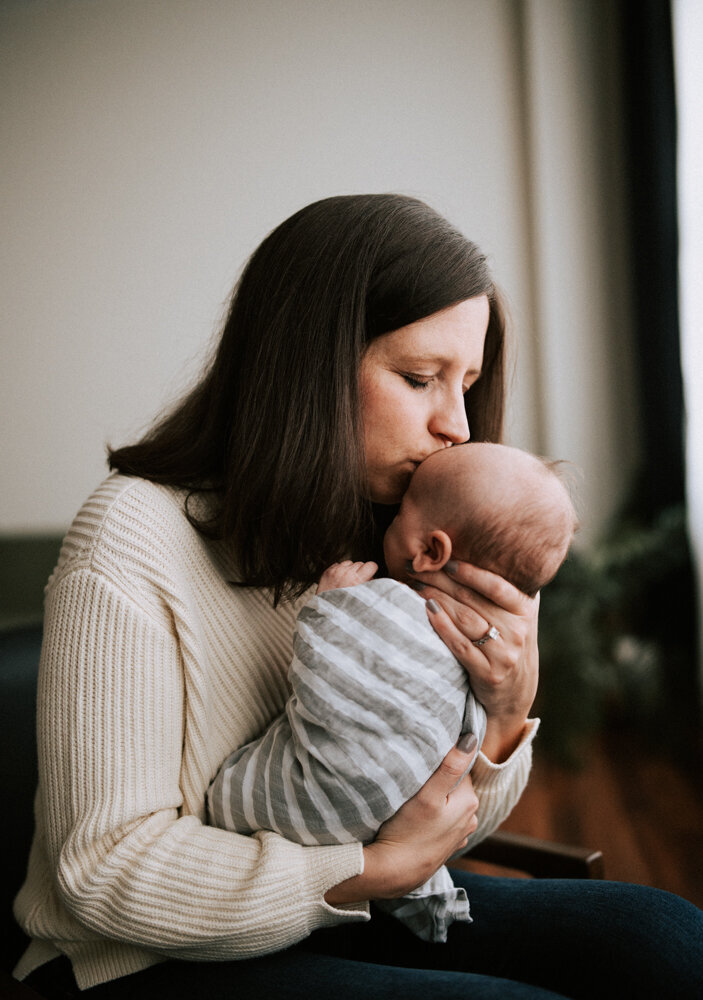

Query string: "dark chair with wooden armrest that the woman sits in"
[[0, 625, 603, 1000]]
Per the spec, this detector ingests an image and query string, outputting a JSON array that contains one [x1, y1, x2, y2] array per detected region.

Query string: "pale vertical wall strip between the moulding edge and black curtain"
[[522, 0, 639, 538]]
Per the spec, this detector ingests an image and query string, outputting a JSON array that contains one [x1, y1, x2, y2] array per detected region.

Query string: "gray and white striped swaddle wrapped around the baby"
[[208, 579, 486, 941]]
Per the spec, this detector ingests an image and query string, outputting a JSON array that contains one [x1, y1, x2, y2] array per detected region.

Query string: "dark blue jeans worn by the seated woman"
[[28, 871, 703, 1000]]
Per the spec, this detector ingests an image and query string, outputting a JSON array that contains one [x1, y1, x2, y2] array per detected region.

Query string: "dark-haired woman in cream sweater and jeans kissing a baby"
[[16, 195, 703, 998]]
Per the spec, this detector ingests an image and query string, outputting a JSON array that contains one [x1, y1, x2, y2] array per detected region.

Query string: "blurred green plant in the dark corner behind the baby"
[[535, 506, 698, 765]]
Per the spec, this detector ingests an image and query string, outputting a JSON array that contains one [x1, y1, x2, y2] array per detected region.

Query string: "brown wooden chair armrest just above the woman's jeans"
[[463, 832, 604, 878]]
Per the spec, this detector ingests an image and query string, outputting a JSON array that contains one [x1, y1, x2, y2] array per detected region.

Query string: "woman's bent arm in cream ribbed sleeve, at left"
[[27, 569, 365, 959]]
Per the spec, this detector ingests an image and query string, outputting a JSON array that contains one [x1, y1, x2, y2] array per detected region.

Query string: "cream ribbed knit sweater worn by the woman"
[[15, 475, 536, 989]]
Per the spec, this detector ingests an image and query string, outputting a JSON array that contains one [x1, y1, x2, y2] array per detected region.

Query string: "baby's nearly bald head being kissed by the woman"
[[383, 443, 578, 596]]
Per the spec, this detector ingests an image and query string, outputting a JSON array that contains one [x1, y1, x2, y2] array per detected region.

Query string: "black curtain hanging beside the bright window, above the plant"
[[622, 0, 684, 516]]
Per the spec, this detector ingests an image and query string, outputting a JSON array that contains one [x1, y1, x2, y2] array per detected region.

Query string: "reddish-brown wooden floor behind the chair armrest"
[[464, 734, 703, 908]]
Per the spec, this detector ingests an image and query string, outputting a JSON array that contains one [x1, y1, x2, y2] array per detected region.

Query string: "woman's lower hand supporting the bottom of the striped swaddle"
[[325, 738, 478, 906]]
